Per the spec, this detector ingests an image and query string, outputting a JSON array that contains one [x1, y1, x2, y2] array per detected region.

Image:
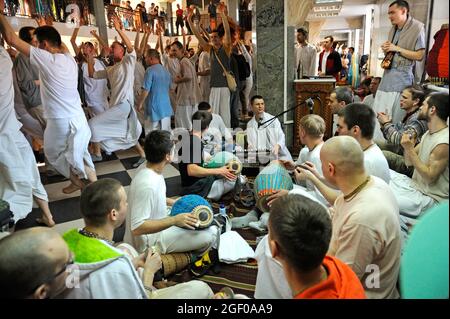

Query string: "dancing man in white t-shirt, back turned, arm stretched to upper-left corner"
[[0, 15, 97, 192]]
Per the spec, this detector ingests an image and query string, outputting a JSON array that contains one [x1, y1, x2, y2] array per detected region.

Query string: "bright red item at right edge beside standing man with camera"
[[427, 29, 449, 78]]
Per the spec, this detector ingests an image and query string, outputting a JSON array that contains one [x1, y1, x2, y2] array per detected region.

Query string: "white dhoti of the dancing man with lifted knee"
[[89, 101, 142, 153]]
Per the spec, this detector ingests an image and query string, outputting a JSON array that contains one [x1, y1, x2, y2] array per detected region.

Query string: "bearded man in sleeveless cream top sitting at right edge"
[[390, 93, 449, 235]]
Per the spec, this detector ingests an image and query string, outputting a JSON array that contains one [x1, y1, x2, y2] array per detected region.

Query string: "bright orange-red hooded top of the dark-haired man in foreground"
[[294, 256, 366, 299]]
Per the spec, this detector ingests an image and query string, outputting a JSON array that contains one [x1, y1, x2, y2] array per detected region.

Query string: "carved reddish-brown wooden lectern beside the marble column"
[[292, 78, 336, 154]]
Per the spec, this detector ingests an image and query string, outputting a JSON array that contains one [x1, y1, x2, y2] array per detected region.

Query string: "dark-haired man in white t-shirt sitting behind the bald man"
[[297, 103, 391, 205]]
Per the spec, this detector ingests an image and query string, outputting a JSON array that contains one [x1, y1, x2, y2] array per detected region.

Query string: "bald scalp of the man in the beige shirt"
[[320, 136, 364, 175]]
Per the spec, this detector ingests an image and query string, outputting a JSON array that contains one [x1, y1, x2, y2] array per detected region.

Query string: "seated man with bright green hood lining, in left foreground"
[[61, 178, 212, 299]]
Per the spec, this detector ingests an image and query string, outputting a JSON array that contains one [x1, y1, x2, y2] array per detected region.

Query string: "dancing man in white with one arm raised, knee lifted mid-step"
[[88, 15, 145, 161]]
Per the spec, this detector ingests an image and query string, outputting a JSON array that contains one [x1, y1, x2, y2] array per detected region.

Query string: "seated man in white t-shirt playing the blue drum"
[[125, 130, 217, 255]]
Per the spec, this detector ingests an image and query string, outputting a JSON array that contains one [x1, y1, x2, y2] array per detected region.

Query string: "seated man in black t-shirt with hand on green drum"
[[178, 111, 236, 201]]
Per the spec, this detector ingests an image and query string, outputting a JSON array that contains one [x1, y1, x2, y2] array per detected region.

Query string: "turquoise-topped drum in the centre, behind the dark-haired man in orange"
[[253, 161, 294, 213]]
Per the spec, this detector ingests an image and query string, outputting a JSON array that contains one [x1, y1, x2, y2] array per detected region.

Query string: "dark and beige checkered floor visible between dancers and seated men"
[[16, 148, 181, 241]]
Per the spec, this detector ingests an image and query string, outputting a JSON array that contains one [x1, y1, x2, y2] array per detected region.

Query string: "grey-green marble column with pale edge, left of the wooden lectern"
[[255, 0, 313, 150]]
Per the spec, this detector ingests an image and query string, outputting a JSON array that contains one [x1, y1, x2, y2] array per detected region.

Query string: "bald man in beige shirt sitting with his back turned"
[[255, 136, 401, 299]]
